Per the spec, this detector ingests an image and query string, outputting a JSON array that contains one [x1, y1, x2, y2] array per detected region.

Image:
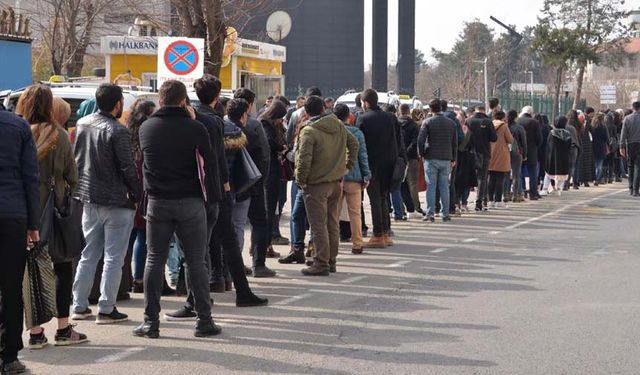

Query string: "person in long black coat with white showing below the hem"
[[542, 116, 572, 194]]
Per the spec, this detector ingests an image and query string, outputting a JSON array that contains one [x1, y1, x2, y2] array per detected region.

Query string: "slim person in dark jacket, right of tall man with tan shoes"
[[398, 104, 424, 214]]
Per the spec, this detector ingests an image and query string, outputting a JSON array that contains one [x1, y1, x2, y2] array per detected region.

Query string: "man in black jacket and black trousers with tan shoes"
[[356, 89, 405, 248]]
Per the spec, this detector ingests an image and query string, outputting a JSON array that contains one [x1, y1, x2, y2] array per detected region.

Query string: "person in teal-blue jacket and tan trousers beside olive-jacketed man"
[[334, 104, 371, 254]]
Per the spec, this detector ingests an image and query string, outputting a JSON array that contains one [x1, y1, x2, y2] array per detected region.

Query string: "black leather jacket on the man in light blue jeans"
[[75, 112, 140, 208]]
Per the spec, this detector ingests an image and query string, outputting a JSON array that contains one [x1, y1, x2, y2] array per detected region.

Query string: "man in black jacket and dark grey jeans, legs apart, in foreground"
[[133, 80, 221, 338]]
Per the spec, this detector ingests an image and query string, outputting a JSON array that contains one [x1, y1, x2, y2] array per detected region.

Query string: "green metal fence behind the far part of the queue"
[[496, 91, 587, 118]]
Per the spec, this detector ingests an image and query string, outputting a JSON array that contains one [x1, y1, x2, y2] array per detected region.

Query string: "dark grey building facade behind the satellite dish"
[[243, 0, 364, 98]]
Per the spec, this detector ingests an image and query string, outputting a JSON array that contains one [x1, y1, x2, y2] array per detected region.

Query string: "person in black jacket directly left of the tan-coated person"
[[467, 106, 498, 211]]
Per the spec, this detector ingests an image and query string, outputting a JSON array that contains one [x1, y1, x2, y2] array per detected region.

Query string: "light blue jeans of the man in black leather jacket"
[[73, 203, 135, 314]]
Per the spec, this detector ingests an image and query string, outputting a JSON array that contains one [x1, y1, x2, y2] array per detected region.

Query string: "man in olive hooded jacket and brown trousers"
[[295, 96, 360, 276]]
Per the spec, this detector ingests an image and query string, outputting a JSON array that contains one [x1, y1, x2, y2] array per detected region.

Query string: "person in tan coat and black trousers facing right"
[[489, 111, 513, 208]]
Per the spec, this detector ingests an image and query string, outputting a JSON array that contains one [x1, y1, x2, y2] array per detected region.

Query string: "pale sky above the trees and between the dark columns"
[[364, 0, 640, 66]]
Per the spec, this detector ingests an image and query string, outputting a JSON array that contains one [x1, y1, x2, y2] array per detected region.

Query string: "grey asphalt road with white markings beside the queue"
[[21, 184, 640, 375]]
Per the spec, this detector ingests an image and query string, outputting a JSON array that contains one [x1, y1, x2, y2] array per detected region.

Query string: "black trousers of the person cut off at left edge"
[[0, 219, 27, 362]]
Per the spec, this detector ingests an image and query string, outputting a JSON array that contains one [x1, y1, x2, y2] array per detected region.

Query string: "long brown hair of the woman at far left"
[[16, 84, 54, 125]]
